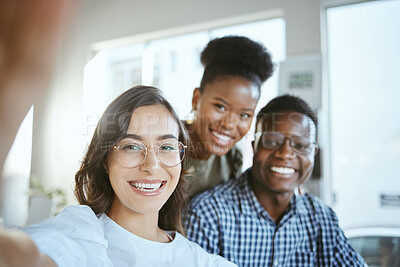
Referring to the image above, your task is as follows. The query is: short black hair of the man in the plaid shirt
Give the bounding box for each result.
[257,94,318,126]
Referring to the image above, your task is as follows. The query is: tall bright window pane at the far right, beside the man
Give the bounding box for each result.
[327,1,400,228]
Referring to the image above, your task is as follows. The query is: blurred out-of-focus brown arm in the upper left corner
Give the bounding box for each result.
[0,0,79,173]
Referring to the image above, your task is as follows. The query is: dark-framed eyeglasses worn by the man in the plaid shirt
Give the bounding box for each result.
[255,132,318,154]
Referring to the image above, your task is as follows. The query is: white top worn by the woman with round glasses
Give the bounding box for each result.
[21,205,236,267]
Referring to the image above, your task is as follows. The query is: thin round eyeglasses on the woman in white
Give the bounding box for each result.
[114,141,186,168]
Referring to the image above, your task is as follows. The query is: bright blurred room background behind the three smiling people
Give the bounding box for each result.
[0,0,400,266]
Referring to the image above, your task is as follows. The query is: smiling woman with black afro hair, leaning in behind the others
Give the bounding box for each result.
[186,36,273,196]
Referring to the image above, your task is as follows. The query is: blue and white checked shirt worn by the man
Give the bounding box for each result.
[184,170,365,267]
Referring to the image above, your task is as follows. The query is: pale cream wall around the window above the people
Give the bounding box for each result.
[26,0,362,207]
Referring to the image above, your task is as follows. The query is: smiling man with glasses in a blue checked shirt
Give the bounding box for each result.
[185,95,365,267]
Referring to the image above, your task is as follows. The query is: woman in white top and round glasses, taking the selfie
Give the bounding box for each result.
[18,86,235,266]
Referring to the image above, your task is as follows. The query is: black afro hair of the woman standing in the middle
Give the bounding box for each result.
[200,36,274,91]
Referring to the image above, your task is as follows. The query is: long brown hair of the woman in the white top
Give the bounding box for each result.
[75,85,188,233]
